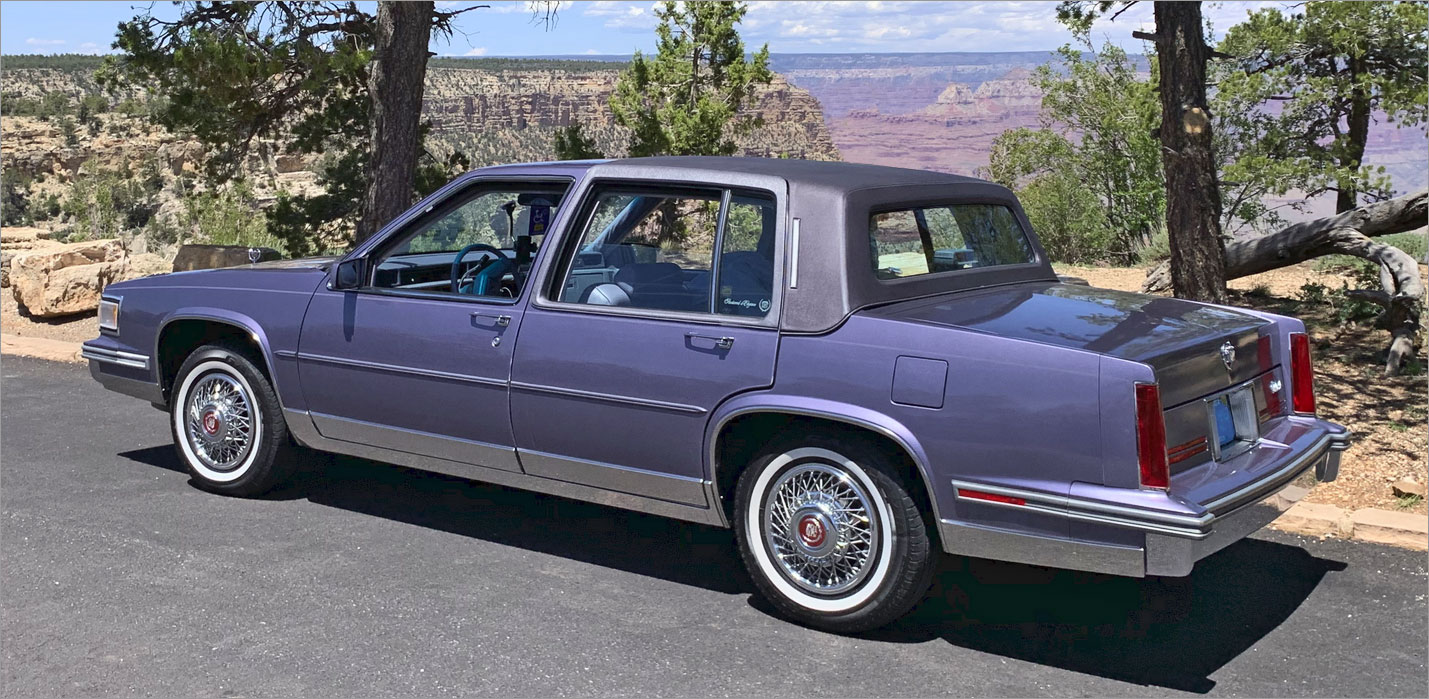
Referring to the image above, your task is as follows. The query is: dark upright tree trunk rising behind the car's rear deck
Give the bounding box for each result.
[1156,1,1226,303]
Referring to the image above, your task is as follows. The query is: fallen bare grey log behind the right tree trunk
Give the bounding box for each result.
[1142,190,1429,376]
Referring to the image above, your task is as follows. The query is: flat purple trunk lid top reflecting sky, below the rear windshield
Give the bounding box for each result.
[872,282,1266,363]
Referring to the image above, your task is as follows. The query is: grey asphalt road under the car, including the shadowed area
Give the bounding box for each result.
[0,357,1429,696]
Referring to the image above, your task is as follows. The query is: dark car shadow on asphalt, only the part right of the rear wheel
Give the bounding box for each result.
[867,539,1348,693]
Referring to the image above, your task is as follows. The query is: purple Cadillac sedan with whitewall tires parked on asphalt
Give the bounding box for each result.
[84,157,1349,632]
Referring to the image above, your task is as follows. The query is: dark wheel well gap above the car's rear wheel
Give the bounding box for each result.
[713,412,936,530]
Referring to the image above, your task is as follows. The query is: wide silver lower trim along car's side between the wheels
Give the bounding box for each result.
[283,409,725,526]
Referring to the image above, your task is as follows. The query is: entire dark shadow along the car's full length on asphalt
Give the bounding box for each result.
[120,446,1346,693]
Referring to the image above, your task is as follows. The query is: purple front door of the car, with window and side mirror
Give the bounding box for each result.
[297,180,566,473]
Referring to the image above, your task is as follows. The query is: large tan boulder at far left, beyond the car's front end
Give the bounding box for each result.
[10,239,129,317]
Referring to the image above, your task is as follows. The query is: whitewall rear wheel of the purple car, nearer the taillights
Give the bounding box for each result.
[735,433,936,633]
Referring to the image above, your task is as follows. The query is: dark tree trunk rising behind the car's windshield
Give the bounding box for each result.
[357,1,434,242]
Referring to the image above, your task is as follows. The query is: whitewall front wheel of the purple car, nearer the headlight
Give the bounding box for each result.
[169,344,293,496]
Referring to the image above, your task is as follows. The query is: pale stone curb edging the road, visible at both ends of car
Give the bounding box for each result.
[0,333,1429,550]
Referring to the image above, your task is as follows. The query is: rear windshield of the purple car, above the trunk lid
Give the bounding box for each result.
[869,204,1036,280]
